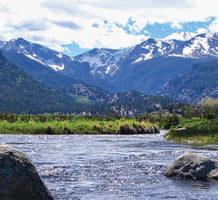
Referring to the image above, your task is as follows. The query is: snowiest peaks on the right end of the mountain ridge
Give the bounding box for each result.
[131,33,218,64]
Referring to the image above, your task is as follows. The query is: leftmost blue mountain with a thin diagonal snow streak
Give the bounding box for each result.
[0,38,84,88]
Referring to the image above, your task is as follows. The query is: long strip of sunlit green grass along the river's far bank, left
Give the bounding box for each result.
[0,117,158,134]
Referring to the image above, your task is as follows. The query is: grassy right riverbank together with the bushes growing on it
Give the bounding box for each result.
[166,97,218,145]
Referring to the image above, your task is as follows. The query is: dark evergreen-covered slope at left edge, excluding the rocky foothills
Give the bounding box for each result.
[0,50,78,113]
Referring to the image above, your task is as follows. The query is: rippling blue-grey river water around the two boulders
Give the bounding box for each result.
[0,130,218,200]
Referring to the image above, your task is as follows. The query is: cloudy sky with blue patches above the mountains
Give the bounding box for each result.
[0,0,218,56]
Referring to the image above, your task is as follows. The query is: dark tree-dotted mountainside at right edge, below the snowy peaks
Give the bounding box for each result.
[159,60,218,103]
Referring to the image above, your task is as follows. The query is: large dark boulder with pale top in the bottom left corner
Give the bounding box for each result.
[0,143,54,200]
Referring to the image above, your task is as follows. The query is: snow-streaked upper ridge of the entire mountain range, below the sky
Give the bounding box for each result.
[0,32,218,79]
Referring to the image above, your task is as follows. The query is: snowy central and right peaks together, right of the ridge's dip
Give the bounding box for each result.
[71,32,218,78]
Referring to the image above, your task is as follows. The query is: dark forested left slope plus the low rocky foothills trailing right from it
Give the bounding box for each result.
[0,50,181,116]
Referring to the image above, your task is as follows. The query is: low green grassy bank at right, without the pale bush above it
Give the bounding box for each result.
[165,118,218,146]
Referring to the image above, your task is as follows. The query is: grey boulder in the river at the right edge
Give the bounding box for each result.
[165,153,218,180]
